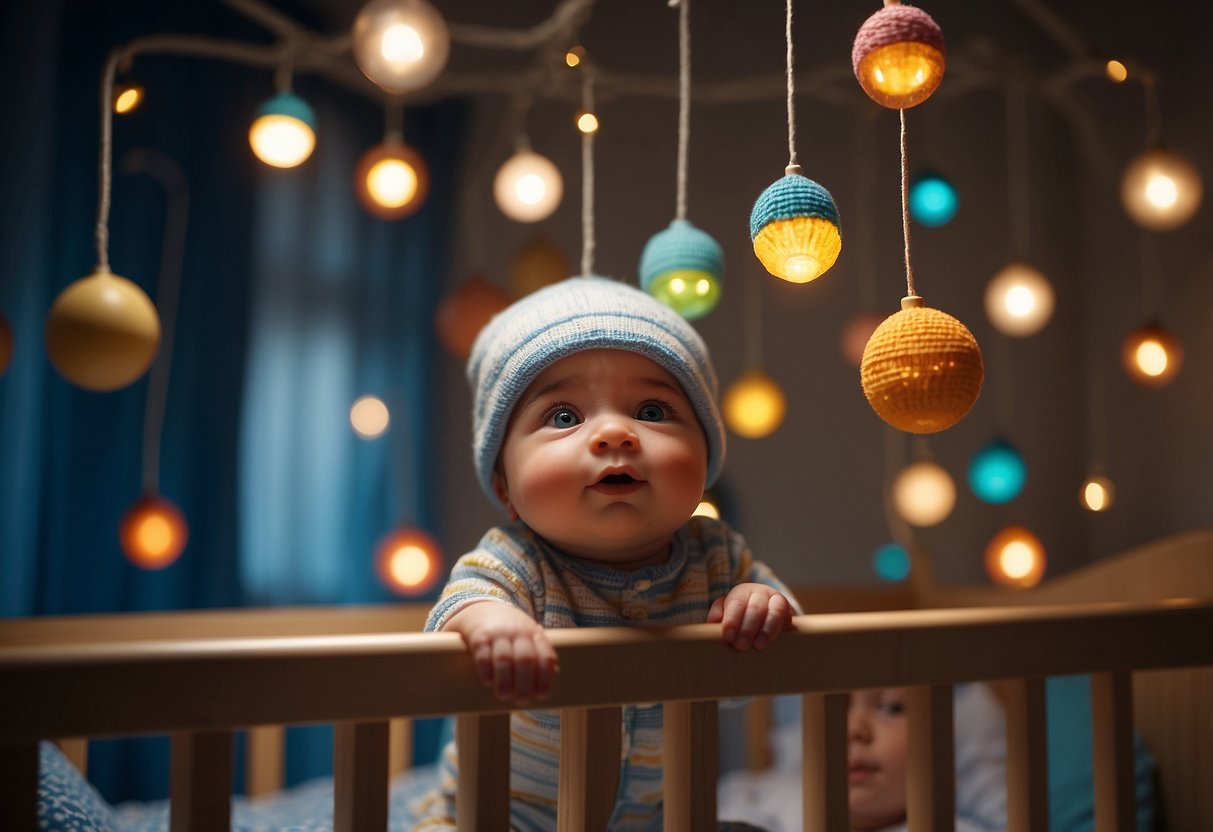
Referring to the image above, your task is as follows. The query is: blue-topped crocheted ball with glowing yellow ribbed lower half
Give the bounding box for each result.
[750,166,842,283]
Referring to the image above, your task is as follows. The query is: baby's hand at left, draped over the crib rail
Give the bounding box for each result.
[443,602,559,705]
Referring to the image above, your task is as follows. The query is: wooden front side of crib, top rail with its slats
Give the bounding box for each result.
[0,599,1213,831]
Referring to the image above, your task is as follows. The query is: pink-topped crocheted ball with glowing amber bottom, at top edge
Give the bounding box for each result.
[850,2,947,109]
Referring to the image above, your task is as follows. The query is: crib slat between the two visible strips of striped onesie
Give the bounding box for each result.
[556,707,622,832]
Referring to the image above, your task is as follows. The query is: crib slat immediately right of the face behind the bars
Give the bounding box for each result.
[906,685,956,832]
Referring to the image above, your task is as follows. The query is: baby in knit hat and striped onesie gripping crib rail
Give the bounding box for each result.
[416,278,799,830]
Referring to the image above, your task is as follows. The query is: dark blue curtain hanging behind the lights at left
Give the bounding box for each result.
[0,0,465,800]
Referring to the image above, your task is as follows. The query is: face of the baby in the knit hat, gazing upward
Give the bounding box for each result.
[495,349,707,569]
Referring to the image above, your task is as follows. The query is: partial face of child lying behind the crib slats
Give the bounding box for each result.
[847,688,907,830]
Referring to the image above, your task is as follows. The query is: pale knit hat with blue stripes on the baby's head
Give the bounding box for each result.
[467,277,724,509]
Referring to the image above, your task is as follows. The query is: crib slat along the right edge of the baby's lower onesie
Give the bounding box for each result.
[662,700,719,832]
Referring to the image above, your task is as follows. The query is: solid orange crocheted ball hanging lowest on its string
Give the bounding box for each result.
[859,295,984,433]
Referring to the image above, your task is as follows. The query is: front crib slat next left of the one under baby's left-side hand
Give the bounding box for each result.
[332,719,389,832]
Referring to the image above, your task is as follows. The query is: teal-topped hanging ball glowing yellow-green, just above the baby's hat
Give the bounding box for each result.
[640,220,724,320]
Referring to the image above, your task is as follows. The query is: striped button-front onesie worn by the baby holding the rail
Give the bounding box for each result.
[414,517,801,832]
